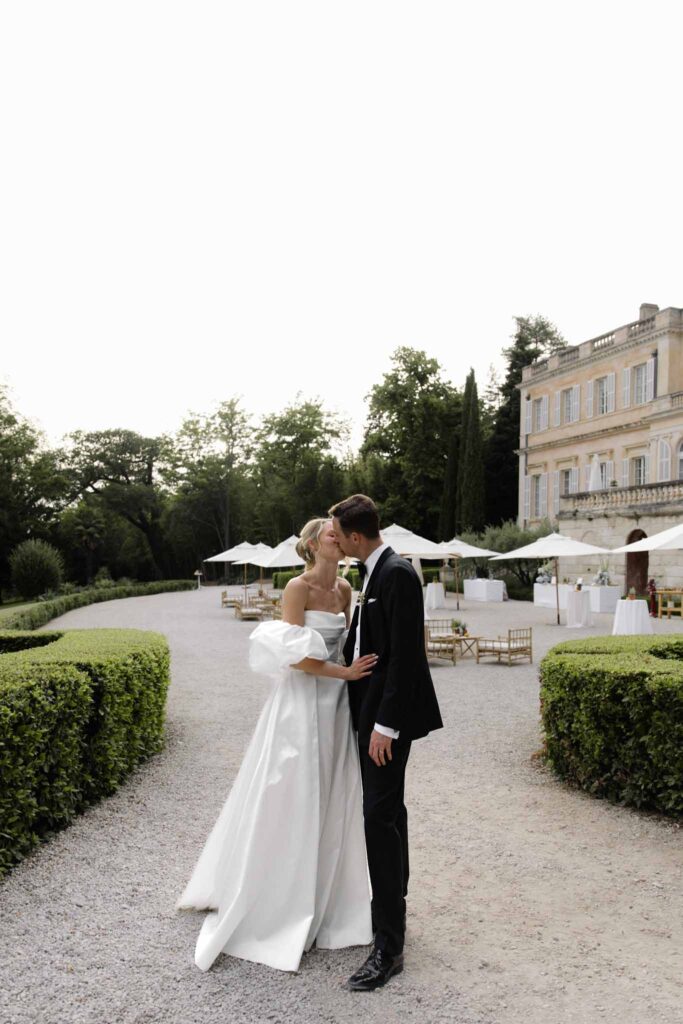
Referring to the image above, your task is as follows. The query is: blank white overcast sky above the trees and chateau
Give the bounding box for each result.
[0,0,683,441]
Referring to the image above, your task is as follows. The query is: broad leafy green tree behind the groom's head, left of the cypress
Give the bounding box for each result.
[360,347,461,538]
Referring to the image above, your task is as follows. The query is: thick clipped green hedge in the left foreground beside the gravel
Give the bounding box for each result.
[0,630,169,876]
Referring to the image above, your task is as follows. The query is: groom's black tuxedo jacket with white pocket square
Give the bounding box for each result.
[344,548,443,740]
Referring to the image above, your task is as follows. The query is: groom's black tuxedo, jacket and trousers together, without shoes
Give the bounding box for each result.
[344,548,443,956]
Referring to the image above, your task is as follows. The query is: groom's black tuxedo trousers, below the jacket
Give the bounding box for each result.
[358,737,411,956]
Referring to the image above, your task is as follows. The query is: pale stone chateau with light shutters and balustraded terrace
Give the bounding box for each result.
[519,304,683,593]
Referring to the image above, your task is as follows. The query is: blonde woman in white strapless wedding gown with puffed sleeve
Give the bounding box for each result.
[177,519,376,971]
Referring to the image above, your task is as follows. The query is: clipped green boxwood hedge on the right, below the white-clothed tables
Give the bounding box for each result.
[541,636,683,816]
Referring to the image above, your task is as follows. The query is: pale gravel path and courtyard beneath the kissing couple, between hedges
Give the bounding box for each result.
[0,589,683,1024]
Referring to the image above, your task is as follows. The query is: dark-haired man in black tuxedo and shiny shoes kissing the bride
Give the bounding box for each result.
[329,495,443,991]
